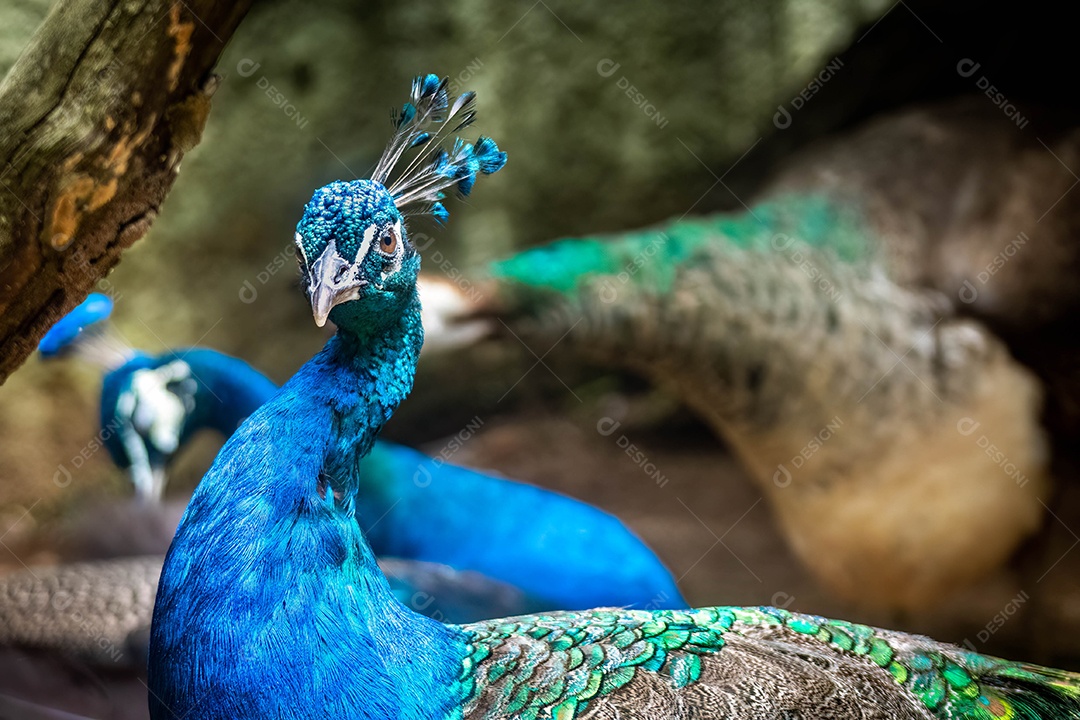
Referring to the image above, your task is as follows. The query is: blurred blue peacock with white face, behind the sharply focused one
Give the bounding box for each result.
[40,294,686,622]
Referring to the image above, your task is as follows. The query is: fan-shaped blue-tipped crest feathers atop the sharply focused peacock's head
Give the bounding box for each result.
[372,73,507,222]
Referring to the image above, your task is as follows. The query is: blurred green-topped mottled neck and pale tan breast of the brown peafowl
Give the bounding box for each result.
[478,187,1049,608]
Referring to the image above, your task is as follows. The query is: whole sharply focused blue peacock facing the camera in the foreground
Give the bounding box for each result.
[149,74,1080,720]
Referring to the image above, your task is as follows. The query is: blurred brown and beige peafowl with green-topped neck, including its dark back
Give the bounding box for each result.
[432,98,1080,611]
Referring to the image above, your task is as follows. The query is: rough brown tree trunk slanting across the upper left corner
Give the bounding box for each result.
[0,0,251,383]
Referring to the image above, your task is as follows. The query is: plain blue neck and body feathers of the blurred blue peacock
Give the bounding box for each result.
[102,334,687,610]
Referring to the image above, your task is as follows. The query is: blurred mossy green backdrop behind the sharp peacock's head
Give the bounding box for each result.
[0,0,888,524]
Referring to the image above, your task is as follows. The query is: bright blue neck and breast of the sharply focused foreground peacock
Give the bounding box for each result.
[149,298,463,720]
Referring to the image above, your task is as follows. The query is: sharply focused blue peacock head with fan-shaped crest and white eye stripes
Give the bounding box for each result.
[296,74,507,327]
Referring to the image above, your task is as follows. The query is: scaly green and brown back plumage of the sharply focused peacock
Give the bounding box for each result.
[457,608,1080,720]
